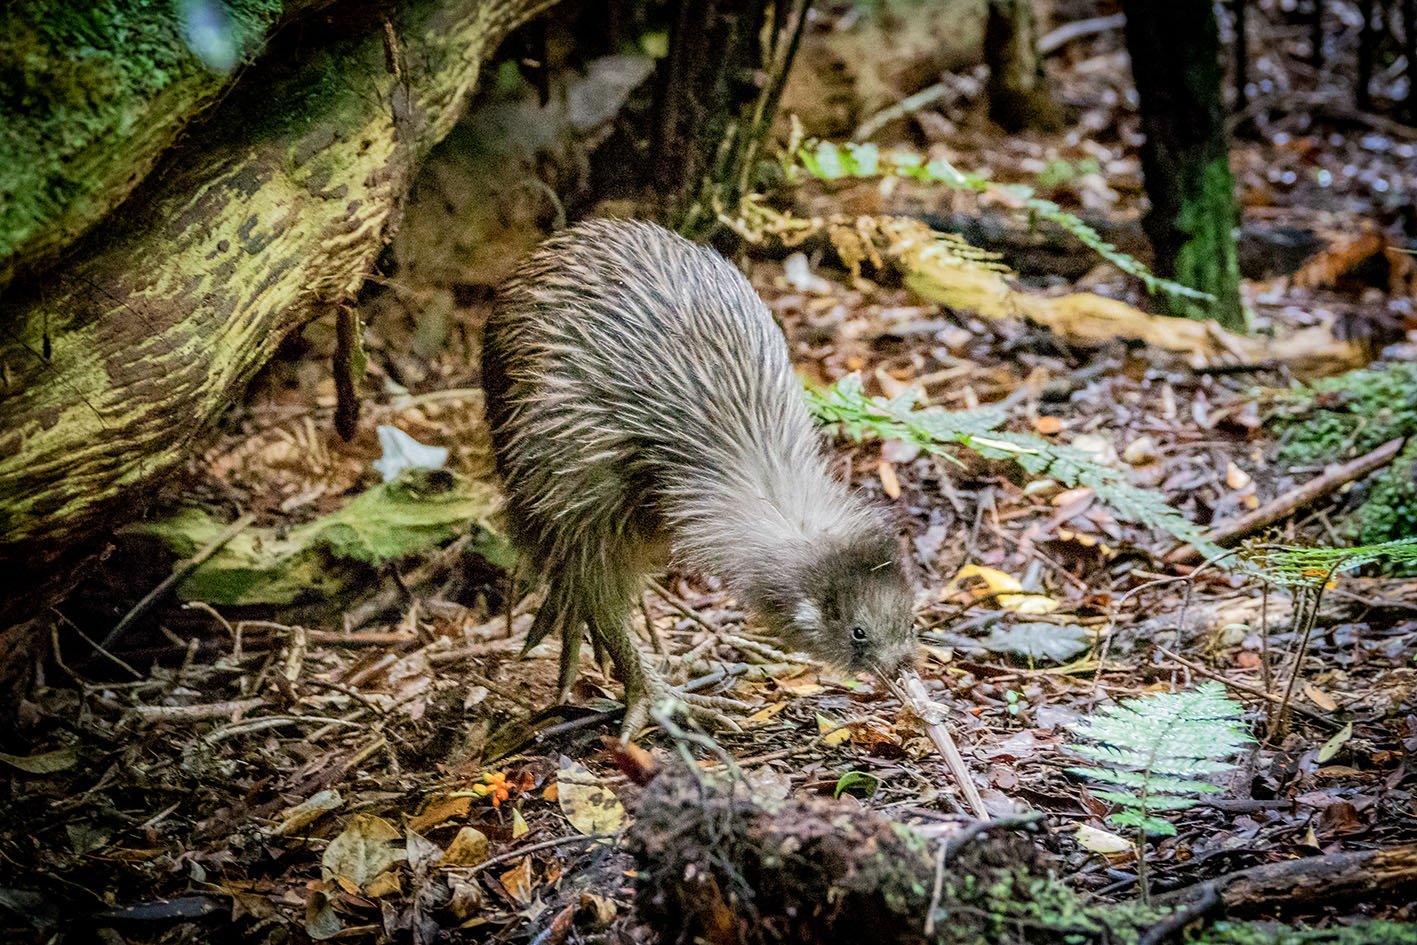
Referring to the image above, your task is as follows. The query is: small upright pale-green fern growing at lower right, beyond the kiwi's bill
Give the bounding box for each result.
[1068,683,1253,898]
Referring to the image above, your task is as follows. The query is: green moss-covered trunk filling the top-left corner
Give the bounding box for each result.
[0,0,316,286]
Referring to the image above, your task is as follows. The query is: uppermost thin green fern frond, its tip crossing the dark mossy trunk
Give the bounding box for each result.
[782,140,1214,302]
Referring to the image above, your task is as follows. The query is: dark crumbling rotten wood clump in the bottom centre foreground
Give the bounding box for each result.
[626,771,1054,945]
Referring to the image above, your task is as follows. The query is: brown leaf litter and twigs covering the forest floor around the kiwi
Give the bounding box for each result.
[0,1,1417,944]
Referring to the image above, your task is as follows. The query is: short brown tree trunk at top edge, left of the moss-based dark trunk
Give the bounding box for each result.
[983,0,1063,133]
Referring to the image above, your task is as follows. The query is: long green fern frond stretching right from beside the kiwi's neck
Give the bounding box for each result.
[808,374,1223,557]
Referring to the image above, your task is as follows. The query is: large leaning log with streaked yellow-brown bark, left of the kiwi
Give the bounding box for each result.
[0,0,551,618]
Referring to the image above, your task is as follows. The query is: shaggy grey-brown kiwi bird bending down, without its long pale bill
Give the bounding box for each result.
[482,221,917,734]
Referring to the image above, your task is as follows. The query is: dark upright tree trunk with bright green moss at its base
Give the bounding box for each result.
[1122,0,1246,329]
